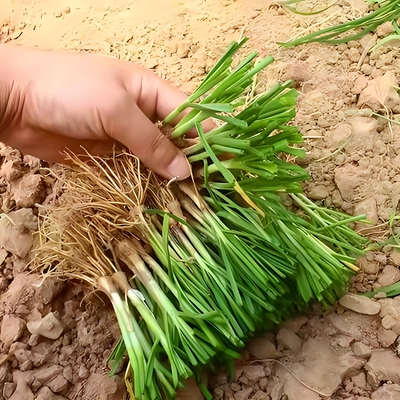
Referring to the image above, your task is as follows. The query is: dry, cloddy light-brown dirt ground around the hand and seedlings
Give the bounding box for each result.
[0,0,400,400]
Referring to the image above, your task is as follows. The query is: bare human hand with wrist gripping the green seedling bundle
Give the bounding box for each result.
[0,45,200,179]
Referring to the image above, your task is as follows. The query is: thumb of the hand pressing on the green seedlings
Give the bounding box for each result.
[110,102,191,180]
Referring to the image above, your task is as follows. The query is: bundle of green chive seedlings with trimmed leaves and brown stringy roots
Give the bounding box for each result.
[35,39,365,400]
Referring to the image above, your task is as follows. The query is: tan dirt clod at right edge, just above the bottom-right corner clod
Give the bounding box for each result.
[365,349,400,384]
